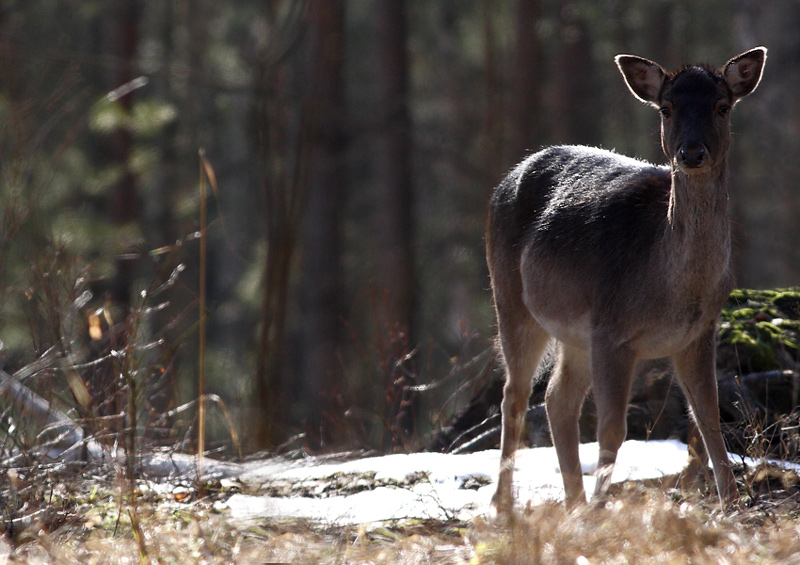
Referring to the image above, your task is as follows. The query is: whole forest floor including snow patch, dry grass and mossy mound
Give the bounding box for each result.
[0,289,800,565]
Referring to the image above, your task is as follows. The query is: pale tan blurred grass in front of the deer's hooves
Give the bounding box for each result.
[473,480,800,564]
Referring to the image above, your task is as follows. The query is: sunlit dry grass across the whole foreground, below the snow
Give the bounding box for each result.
[0,477,800,564]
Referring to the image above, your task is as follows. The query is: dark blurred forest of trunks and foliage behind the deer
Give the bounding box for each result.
[0,0,800,451]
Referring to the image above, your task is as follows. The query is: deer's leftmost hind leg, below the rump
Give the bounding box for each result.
[492,300,549,518]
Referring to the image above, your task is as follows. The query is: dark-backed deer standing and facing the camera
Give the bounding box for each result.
[486,47,767,518]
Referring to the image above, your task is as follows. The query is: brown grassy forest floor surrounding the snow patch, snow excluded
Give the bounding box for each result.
[0,442,800,564]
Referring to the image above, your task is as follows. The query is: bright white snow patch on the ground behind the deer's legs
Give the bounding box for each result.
[220,440,756,526]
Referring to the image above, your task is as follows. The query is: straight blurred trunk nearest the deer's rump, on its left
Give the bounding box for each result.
[375,0,415,450]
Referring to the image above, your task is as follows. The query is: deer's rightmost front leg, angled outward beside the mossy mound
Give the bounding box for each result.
[673,323,738,506]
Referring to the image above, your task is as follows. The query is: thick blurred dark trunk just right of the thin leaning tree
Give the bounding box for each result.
[300,0,345,450]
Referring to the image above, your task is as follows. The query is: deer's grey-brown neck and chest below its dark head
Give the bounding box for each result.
[666,163,730,294]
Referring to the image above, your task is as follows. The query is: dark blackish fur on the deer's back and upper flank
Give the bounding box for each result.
[489,146,670,286]
